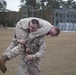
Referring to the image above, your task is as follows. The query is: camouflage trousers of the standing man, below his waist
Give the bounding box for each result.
[18,60,41,75]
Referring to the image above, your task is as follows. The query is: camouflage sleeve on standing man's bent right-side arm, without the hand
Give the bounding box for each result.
[32,39,46,59]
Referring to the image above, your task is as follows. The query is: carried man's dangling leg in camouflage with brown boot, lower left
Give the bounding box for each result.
[0,44,23,73]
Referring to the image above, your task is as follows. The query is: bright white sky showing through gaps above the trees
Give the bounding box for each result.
[5,0,76,11]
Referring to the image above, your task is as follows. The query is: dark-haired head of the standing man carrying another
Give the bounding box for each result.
[29,19,40,32]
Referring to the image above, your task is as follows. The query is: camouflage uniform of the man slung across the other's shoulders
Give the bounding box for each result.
[4,17,53,53]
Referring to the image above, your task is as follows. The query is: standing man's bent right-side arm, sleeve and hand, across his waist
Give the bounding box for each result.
[26,39,46,60]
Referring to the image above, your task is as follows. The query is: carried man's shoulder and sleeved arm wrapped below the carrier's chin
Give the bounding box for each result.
[29,19,53,39]
